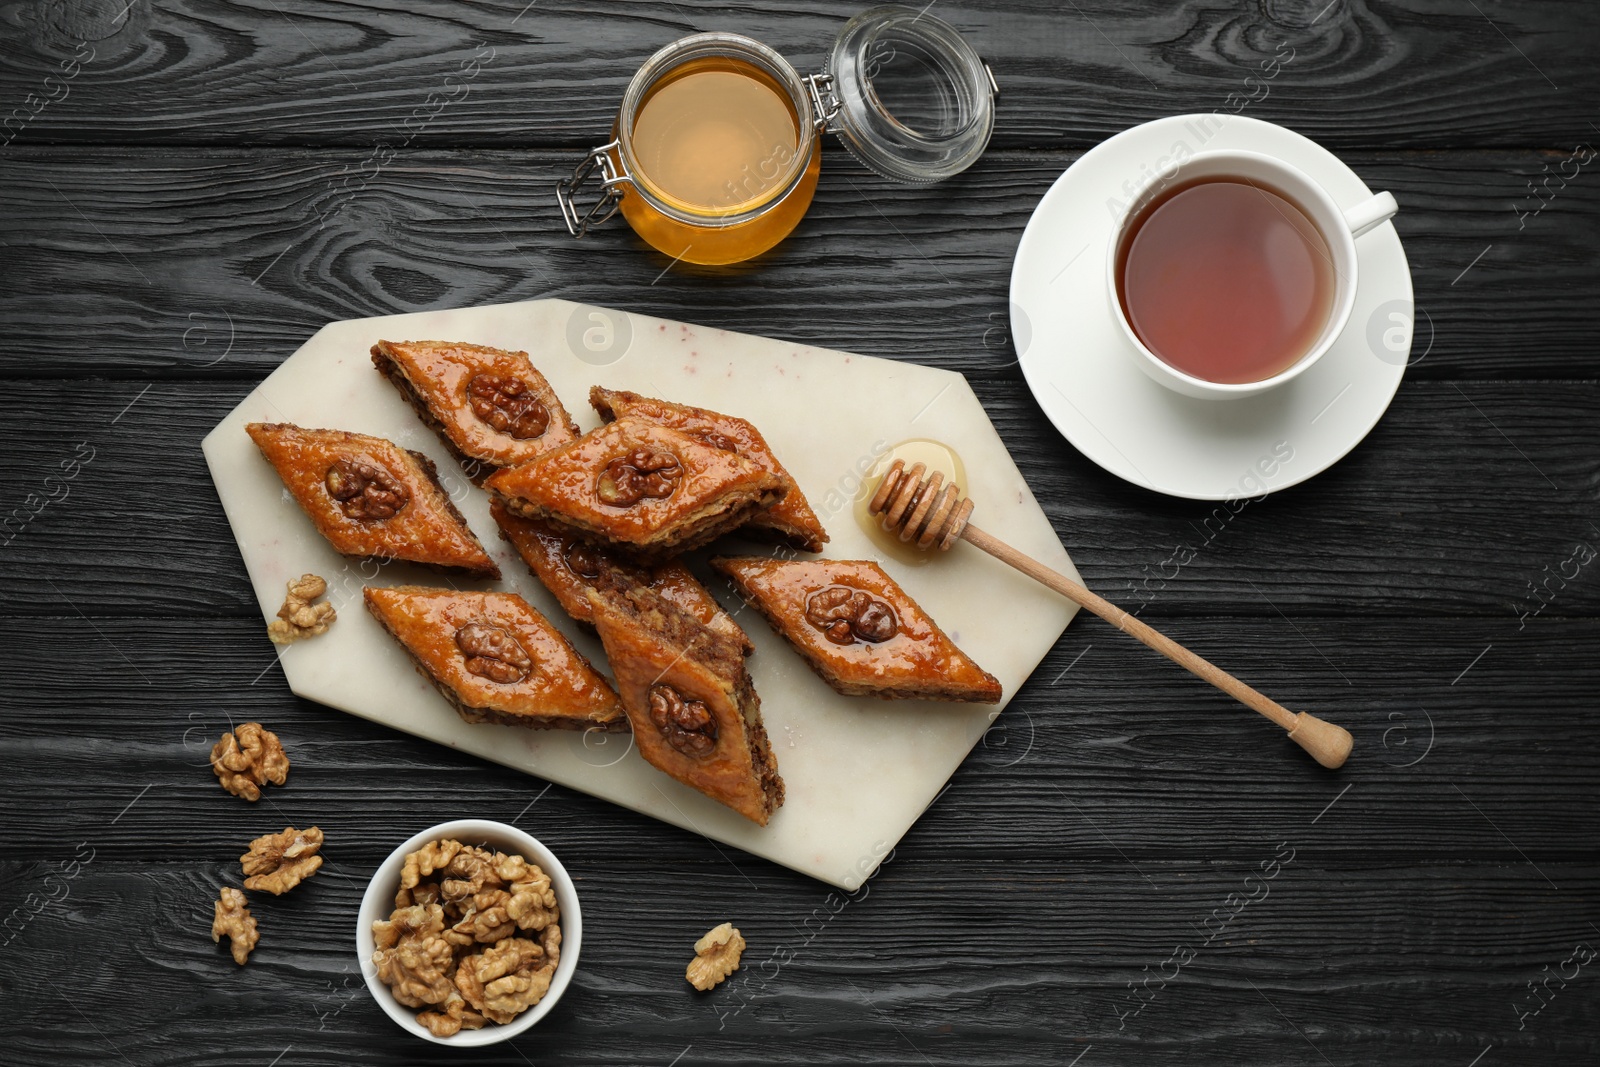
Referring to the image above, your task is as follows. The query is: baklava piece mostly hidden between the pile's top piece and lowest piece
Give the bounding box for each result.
[490,501,755,656]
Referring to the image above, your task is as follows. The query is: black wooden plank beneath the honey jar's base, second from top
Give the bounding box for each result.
[0,146,1600,382]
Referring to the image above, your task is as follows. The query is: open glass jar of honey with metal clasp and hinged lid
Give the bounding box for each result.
[557,6,998,264]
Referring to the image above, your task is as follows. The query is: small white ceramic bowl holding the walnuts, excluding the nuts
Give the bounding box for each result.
[355,819,584,1048]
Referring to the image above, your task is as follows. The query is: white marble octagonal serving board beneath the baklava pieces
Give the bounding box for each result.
[203,299,1077,889]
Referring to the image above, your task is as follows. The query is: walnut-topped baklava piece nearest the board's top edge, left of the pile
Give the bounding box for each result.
[373,341,578,485]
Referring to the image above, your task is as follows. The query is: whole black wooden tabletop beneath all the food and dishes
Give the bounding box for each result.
[0,0,1600,1067]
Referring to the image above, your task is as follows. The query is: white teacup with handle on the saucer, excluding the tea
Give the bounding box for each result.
[1106,149,1400,400]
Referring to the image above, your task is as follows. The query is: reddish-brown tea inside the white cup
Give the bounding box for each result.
[1115,174,1338,384]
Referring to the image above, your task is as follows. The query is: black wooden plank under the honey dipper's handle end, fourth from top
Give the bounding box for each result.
[0,616,1600,857]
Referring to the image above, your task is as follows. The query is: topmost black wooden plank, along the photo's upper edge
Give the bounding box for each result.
[0,0,1600,149]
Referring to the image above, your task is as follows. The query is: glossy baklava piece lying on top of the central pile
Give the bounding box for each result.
[486,419,784,563]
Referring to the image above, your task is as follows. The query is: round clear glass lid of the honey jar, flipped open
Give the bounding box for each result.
[826,5,995,184]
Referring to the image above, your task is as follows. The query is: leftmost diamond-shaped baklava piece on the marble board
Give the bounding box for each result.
[245,422,499,577]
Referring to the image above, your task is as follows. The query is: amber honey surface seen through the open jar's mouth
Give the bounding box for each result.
[632,58,800,214]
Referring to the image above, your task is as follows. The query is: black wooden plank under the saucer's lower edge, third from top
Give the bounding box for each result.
[0,374,1600,617]
